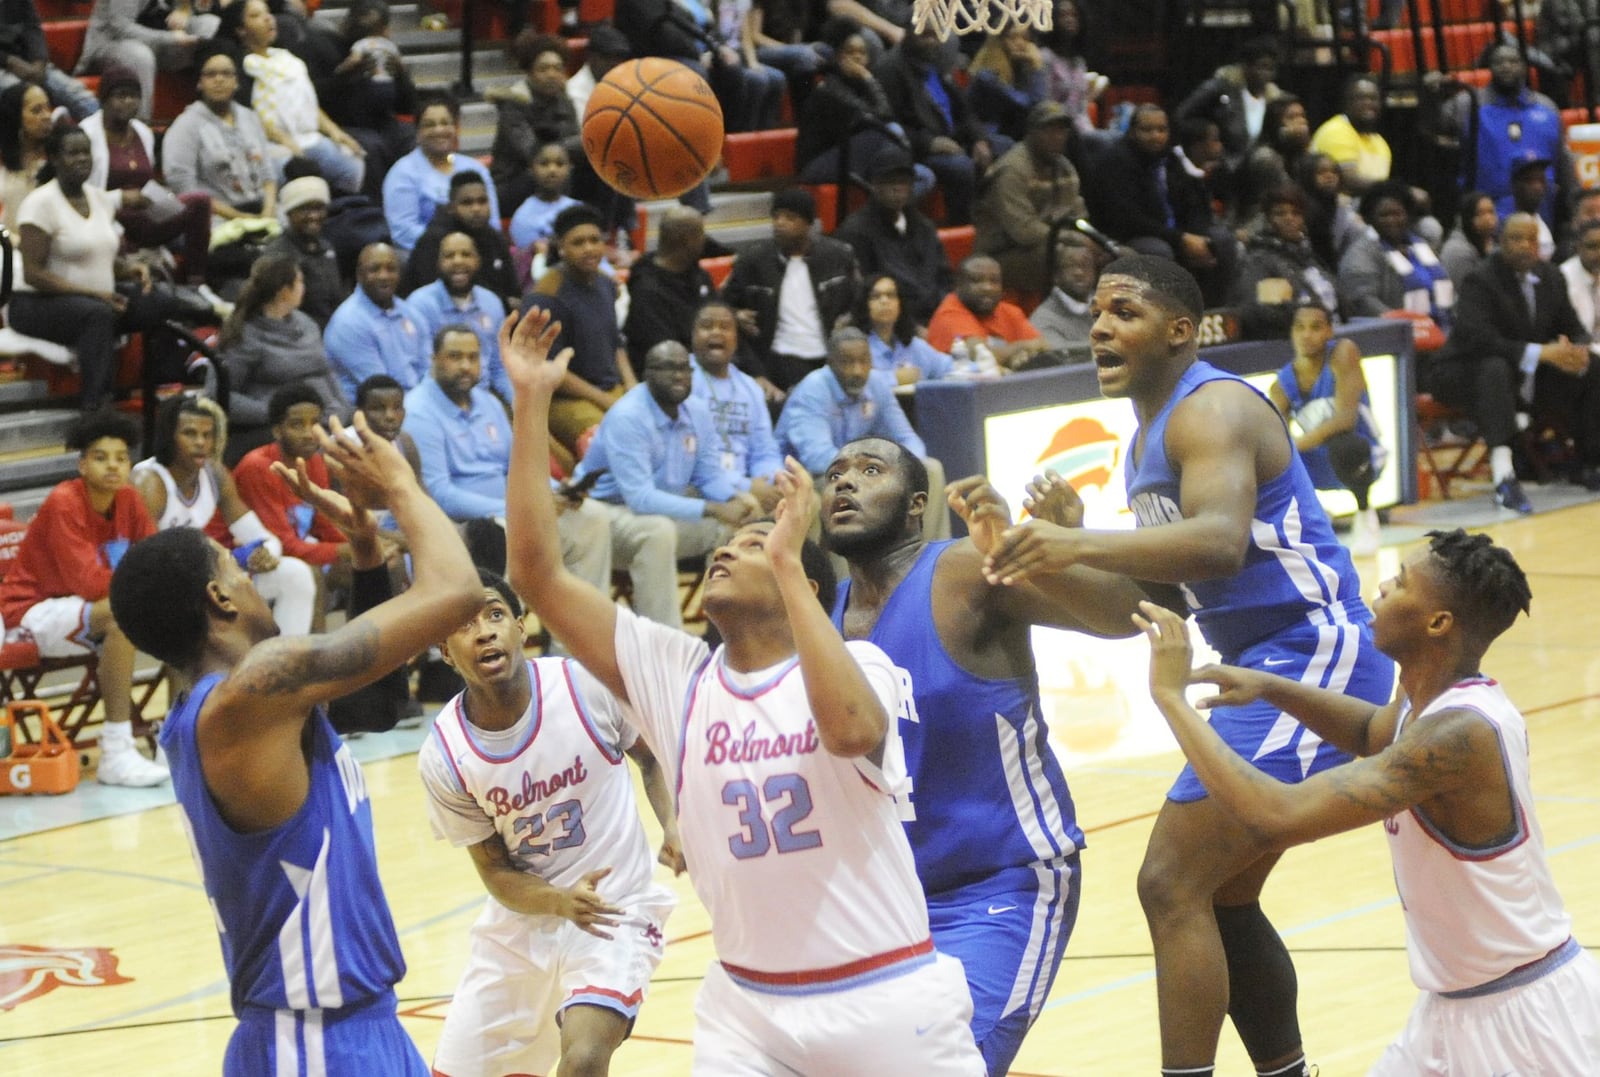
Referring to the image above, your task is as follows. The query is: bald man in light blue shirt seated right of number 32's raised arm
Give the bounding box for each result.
[574,341,758,559]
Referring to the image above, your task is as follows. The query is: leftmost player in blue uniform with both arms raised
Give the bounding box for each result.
[110,414,483,1077]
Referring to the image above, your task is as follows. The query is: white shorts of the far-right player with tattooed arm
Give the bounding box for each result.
[1370,951,1600,1077]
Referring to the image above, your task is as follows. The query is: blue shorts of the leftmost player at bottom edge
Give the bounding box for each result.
[222,992,429,1077]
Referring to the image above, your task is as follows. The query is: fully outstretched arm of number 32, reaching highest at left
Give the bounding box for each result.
[499,309,627,701]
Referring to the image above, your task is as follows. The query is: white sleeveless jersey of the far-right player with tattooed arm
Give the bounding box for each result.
[1384,679,1573,991]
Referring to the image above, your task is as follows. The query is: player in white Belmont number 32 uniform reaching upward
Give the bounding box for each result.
[501,314,984,1077]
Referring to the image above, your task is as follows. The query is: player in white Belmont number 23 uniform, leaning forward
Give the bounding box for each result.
[418,571,682,1077]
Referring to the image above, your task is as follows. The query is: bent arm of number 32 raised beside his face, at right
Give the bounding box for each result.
[766,456,890,763]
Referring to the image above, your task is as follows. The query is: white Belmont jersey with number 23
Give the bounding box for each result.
[418,658,674,907]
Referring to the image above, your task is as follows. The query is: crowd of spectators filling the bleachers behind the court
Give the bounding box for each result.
[9,0,1600,776]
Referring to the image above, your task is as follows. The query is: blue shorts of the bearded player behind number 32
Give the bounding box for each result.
[928,853,1082,1077]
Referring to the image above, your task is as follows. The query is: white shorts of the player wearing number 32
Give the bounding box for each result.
[693,954,986,1077]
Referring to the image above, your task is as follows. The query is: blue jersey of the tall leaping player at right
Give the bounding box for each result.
[1126,360,1371,661]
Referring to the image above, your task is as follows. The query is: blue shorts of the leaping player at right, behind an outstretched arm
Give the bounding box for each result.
[1166,621,1395,803]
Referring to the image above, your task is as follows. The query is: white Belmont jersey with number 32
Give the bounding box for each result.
[618,610,930,984]
